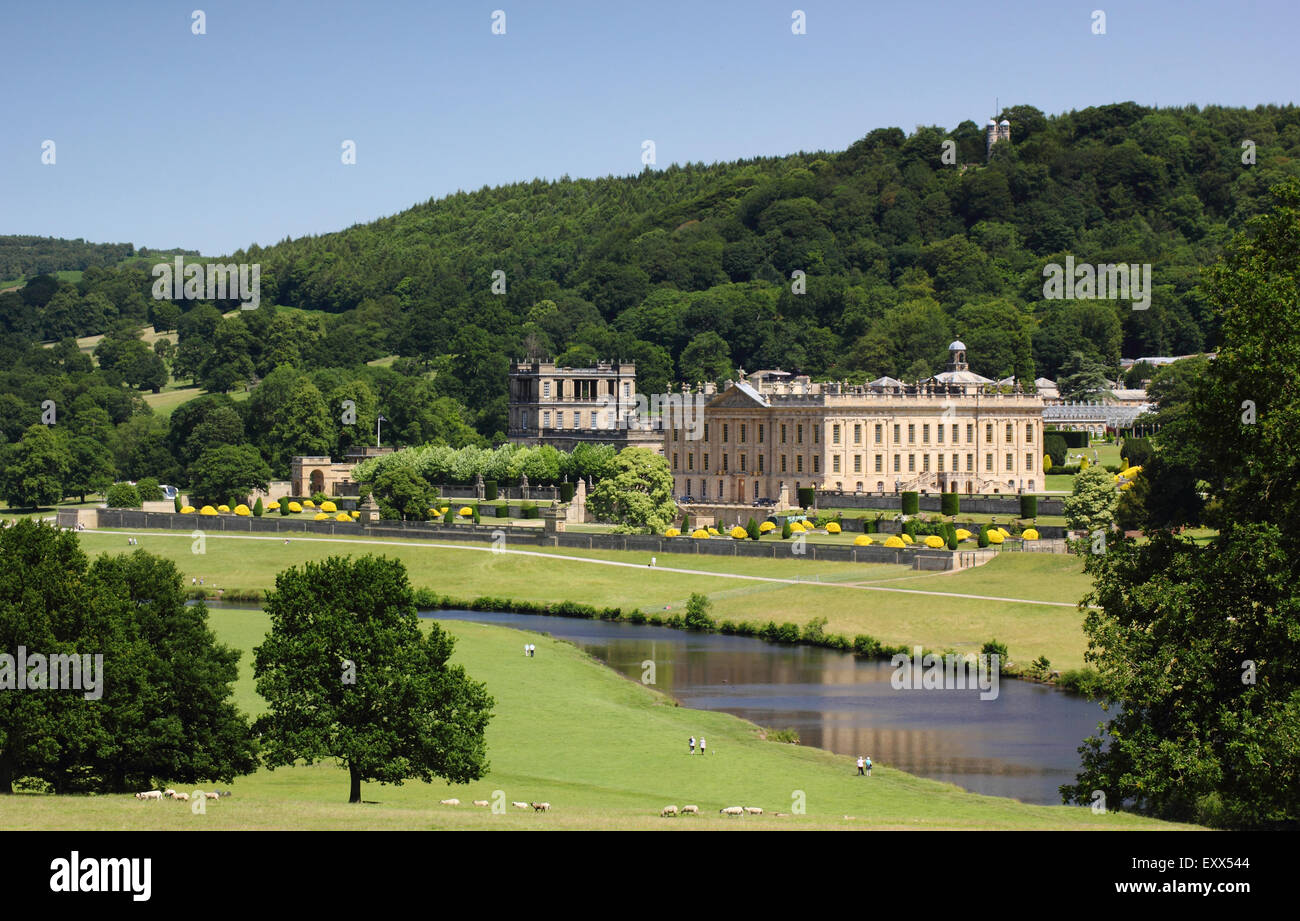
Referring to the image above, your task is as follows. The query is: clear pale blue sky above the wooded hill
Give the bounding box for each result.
[0,0,1300,255]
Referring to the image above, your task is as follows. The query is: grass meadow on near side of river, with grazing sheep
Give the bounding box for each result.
[0,610,1183,830]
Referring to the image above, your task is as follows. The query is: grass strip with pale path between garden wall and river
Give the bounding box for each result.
[81,523,1087,669]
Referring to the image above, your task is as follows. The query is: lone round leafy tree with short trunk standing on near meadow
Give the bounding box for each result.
[254,555,493,803]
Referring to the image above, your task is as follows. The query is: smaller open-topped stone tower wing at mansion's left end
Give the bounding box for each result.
[506,362,663,451]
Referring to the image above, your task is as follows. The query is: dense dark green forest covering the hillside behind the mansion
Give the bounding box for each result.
[0,103,1300,496]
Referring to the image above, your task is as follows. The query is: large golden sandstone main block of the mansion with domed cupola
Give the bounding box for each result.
[662,342,1044,503]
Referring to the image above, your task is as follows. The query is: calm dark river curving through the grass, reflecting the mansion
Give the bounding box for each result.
[432,611,1105,804]
